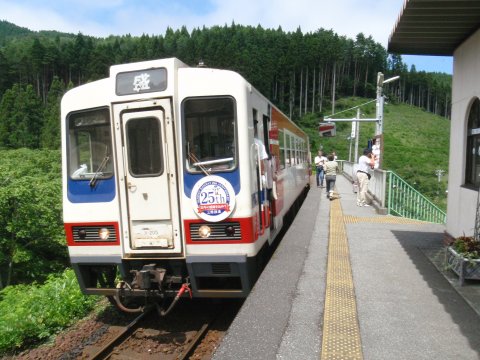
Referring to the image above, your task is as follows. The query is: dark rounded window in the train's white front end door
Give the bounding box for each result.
[126,117,163,177]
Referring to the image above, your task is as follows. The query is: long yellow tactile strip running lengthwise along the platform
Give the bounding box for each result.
[321,201,363,360]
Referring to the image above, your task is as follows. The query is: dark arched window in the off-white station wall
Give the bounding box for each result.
[465,98,480,188]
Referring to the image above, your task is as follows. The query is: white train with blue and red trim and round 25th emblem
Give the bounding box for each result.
[61,58,310,311]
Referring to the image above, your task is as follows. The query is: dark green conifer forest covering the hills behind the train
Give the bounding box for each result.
[0,21,451,149]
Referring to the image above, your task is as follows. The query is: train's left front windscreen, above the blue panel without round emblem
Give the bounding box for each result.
[68,108,113,180]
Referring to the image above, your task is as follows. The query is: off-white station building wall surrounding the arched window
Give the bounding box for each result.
[446,30,480,236]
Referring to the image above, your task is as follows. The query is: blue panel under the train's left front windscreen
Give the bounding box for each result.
[67,176,115,203]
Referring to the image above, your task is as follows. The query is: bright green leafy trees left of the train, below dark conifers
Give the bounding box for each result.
[0,149,68,288]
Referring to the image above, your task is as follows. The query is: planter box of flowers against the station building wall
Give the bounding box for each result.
[445,235,480,286]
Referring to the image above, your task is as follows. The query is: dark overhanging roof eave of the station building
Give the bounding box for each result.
[388,0,480,56]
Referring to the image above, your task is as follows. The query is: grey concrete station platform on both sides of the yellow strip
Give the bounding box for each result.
[213,176,480,360]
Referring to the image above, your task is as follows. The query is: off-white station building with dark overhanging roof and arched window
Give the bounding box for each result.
[388,0,480,237]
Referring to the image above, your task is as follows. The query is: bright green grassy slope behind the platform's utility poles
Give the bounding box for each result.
[302,98,450,209]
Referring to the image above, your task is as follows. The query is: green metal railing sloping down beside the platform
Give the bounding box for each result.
[387,171,447,224]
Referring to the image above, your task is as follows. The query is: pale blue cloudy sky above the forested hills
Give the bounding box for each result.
[0,0,453,74]
